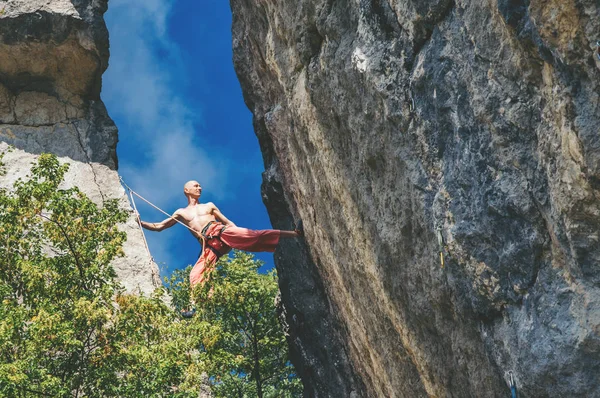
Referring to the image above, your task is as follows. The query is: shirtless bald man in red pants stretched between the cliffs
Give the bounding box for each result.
[140,181,302,287]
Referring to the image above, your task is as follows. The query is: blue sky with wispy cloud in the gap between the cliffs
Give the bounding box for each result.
[102,0,273,275]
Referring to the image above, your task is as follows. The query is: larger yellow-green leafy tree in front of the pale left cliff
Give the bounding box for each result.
[0,155,203,397]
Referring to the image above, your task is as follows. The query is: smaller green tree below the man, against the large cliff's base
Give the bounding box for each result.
[167,251,302,398]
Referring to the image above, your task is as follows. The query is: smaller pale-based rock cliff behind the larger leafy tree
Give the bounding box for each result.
[0,0,160,293]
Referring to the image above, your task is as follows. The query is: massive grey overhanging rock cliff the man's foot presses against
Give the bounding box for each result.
[231,0,600,397]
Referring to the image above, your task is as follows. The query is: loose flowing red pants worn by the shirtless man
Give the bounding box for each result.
[190,222,281,287]
